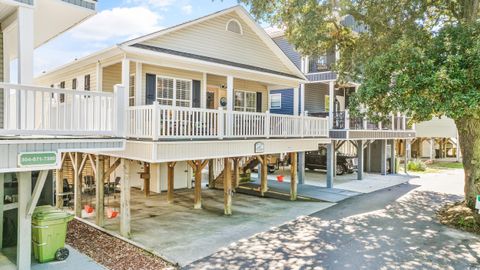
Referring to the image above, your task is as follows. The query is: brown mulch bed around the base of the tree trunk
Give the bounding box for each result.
[437,202,480,234]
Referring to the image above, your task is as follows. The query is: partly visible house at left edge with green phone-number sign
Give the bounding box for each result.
[0,0,124,269]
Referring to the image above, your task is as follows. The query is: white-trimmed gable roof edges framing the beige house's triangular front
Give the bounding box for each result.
[119,5,306,80]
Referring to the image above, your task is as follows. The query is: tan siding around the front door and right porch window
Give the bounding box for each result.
[207,74,268,112]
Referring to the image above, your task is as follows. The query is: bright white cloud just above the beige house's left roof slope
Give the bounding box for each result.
[70,6,163,42]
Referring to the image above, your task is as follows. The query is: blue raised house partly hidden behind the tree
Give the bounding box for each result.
[267,22,415,179]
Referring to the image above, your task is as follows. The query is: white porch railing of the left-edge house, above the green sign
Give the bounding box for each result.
[0,83,124,136]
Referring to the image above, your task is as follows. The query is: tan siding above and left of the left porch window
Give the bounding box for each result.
[140,64,203,104]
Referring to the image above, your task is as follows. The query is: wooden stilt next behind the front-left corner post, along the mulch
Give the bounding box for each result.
[95,155,105,227]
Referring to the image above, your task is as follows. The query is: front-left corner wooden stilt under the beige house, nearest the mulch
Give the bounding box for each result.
[120,159,130,238]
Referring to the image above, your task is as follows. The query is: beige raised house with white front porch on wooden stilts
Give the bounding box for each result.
[35,6,330,236]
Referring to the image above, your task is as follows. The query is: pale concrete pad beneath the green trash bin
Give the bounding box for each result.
[0,245,105,270]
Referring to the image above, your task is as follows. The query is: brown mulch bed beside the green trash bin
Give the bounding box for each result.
[66,219,176,270]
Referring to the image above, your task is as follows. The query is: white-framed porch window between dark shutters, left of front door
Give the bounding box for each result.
[157,76,192,107]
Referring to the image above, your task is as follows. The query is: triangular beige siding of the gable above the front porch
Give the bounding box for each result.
[143,12,291,76]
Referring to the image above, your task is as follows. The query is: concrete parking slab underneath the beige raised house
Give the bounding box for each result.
[87,188,334,266]
